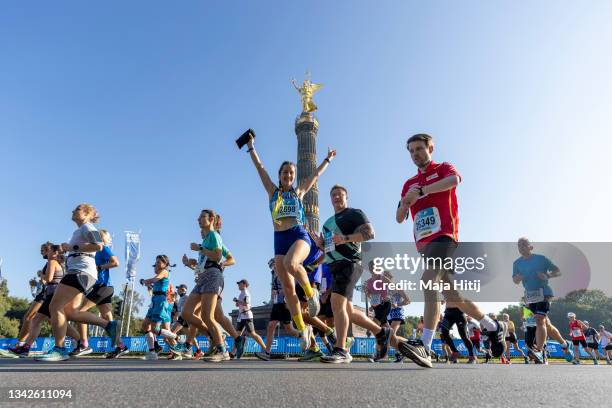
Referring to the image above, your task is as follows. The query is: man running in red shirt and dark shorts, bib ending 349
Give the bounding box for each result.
[395,134,505,367]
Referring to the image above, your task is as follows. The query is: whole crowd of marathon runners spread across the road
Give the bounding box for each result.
[0,134,612,367]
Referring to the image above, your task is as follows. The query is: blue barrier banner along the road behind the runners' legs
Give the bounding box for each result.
[0,336,603,358]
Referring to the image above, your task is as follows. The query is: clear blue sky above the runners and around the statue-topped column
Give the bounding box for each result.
[0,0,612,313]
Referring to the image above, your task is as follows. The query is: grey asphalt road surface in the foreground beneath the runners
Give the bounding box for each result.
[0,358,612,408]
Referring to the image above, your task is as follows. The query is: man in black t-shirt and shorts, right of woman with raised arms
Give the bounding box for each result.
[317,185,391,363]
